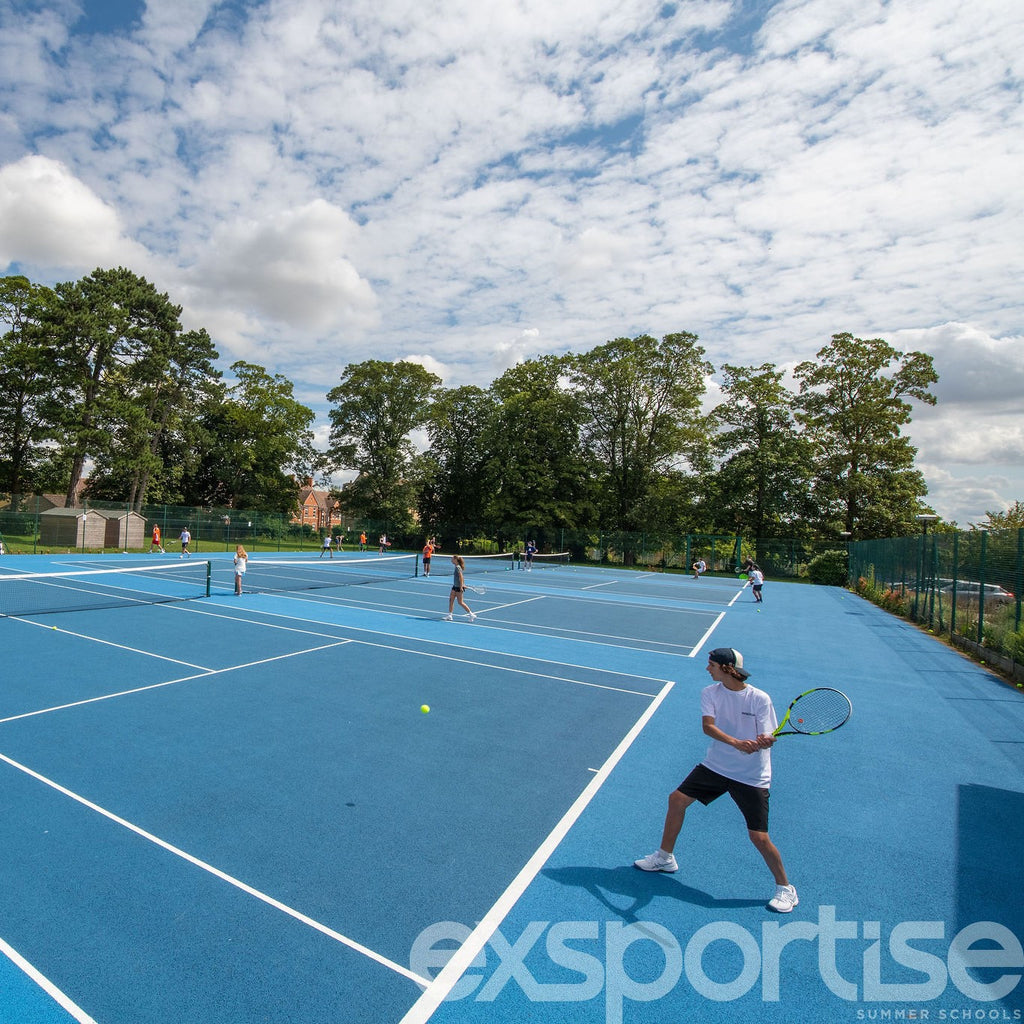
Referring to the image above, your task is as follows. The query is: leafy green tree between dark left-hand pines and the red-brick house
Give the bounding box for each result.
[182,360,315,512]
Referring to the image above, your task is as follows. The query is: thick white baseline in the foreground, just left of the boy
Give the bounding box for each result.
[399,683,674,1024]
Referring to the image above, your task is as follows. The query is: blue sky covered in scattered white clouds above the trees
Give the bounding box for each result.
[0,0,1024,525]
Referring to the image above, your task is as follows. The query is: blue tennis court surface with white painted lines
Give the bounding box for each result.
[0,554,1024,1024]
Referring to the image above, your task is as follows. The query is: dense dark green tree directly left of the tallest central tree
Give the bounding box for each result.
[484,355,591,531]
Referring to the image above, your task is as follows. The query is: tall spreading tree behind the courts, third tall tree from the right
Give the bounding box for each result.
[570,333,712,529]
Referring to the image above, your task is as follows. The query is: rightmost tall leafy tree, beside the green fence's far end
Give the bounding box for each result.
[794,334,938,537]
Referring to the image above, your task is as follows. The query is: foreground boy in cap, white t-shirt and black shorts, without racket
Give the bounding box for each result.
[634,647,800,913]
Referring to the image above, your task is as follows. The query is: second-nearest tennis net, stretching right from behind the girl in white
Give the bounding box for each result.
[213,554,420,594]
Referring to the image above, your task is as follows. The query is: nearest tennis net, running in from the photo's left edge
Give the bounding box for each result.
[0,559,210,617]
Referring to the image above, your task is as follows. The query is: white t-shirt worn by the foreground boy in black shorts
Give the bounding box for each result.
[700,683,778,790]
